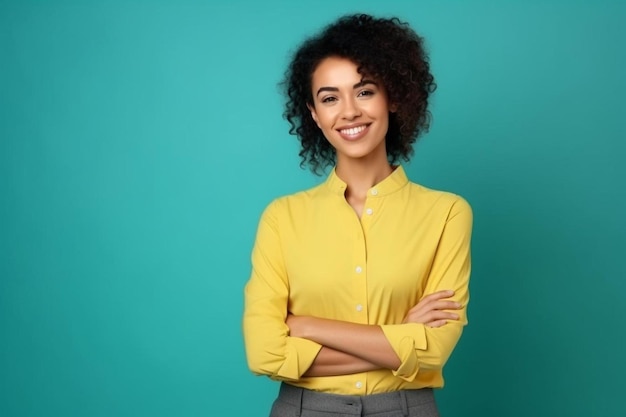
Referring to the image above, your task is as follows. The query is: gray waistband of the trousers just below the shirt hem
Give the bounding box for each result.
[278,382,435,416]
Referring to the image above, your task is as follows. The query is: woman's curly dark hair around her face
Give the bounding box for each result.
[280,14,437,174]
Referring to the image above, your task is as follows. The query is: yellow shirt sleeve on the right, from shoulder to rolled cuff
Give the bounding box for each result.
[381,197,472,381]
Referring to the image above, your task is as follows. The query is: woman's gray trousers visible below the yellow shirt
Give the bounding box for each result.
[270,383,439,417]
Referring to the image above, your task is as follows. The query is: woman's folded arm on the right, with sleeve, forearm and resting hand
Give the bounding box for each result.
[287,199,472,381]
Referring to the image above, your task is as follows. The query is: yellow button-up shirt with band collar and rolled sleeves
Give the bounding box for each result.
[243,167,472,395]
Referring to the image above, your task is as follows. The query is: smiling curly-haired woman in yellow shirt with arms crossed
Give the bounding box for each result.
[244,15,472,416]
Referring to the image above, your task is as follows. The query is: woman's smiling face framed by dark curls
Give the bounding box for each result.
[309,57,394,164]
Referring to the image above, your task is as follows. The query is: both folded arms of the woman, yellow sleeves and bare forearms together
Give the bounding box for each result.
[244,199,471,381]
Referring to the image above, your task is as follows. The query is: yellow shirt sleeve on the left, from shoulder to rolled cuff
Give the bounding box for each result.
[243,200,322,381]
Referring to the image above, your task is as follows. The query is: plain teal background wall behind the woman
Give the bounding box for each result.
[0,0,626,417]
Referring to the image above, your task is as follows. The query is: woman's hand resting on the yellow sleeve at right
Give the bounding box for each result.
[402,290,463,327]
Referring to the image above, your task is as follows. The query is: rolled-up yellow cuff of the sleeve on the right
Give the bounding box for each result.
[381,323,428,382]
